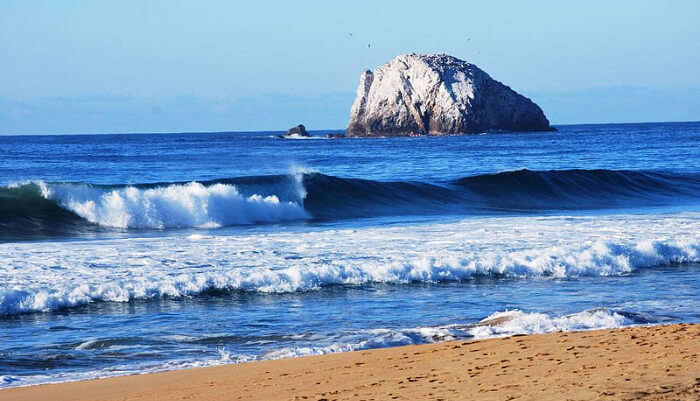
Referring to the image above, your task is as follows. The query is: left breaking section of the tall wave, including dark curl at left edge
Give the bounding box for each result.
[0,175,310,239]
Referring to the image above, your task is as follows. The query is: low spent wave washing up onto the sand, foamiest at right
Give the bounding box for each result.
[0,308,660,389]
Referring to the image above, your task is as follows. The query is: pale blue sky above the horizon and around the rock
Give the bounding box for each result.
[0,0,700,134]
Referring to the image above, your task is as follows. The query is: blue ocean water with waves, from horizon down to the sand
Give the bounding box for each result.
[0,123,700,387]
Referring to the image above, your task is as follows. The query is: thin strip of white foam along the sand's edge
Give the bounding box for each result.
[0,309,635,388]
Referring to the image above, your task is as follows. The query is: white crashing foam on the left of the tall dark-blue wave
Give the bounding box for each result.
[37,182,309,228]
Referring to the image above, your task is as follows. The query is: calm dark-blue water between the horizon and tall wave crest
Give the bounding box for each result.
[0,123,700,184]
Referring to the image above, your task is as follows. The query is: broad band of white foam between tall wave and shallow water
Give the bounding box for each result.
[0,213,700,315]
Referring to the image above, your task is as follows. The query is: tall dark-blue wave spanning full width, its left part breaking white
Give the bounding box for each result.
[0,170,700,240]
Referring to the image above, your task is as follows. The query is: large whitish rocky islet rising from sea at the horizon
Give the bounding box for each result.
[347,54,552,137]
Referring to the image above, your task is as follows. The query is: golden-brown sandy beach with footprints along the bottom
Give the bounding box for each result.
[0,324,700,401]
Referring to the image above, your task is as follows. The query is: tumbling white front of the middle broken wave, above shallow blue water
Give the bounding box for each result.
[0,234,700,316]
